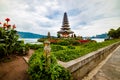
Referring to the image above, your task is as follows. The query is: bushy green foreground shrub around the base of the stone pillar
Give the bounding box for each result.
[28,51,71,80]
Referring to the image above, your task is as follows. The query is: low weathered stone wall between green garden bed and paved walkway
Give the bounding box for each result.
[58,42,120,80]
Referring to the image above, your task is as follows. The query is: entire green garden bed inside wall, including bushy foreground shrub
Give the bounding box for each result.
[28,40,119,80]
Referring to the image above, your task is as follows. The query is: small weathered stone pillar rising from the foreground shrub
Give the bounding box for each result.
[44,40,51,68]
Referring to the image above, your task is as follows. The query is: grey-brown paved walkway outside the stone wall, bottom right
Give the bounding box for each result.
[92,46,120,80]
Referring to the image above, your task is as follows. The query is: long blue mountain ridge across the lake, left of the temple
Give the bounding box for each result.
[18,31,46,38]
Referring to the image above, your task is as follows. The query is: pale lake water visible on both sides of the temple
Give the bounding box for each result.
[19,38,104,44]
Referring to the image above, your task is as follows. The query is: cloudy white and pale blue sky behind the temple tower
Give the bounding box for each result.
[0,0,120,36]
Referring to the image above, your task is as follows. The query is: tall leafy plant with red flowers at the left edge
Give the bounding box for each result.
[0,18,19,57]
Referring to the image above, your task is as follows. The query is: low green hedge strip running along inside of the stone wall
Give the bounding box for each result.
[52,39,120,62]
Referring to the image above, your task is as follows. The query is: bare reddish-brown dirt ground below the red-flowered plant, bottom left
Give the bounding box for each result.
[0,50,33,80]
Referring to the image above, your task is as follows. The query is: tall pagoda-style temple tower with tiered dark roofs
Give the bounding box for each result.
[57,12,74,38]
